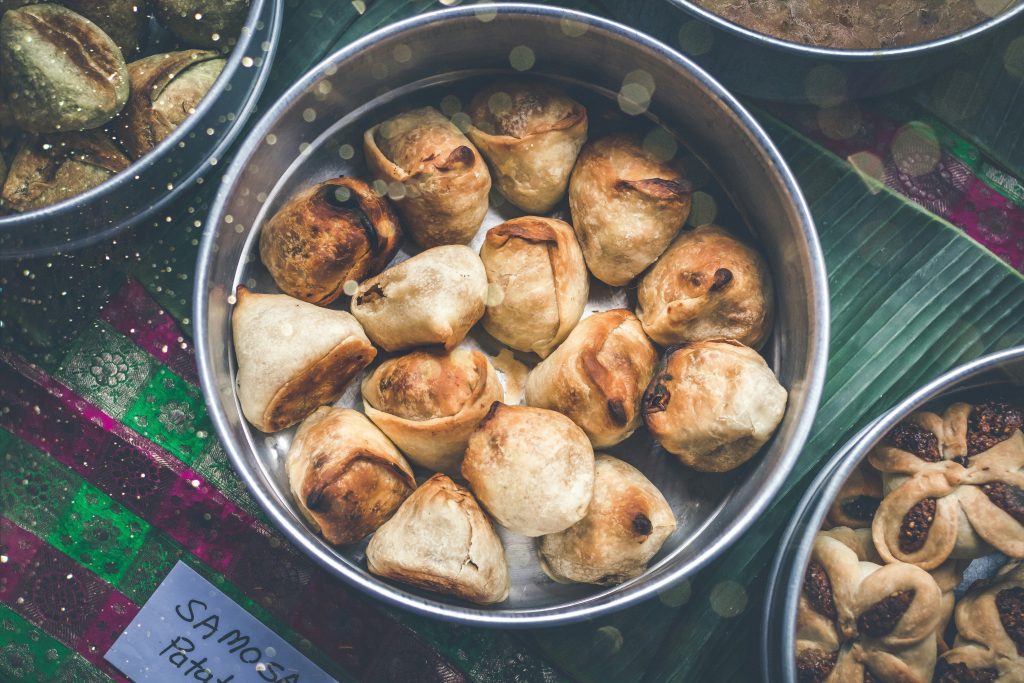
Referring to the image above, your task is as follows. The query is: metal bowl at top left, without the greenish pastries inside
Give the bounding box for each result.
[0,0,284,260]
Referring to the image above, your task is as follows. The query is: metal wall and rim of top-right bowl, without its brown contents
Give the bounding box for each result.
[669,0,1024,104]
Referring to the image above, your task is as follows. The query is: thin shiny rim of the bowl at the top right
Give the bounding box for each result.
[667,0,1024,61]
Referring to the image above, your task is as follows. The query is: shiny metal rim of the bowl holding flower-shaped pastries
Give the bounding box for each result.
[761,346,1024,681]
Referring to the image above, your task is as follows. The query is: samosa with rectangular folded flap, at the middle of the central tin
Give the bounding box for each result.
[480,216,590,358]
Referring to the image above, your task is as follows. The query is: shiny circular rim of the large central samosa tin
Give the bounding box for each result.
[193,3,829,628]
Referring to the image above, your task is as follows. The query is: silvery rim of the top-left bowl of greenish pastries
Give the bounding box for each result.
[0,0,285,254]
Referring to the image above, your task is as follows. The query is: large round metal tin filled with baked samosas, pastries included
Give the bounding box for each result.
[195,5,827,625]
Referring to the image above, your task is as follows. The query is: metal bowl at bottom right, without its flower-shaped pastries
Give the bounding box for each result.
[761,346,1024,682]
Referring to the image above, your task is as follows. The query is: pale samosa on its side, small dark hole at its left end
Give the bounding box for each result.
[352,245,487,351]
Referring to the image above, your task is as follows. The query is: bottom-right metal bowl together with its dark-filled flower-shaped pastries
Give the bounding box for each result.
[765,348,1024,683]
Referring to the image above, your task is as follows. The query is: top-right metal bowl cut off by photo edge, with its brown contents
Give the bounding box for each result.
[669,0,1024,104]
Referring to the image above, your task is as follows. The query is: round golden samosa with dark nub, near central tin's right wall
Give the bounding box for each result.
[637,224,774,349]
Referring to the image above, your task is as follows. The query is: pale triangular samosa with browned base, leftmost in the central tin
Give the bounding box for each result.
[231,287,377,432]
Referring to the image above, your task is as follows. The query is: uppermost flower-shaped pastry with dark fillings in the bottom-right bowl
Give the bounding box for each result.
[868,401,1024,569]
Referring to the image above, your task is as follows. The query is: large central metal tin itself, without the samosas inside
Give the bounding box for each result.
[194,4,828,627]
